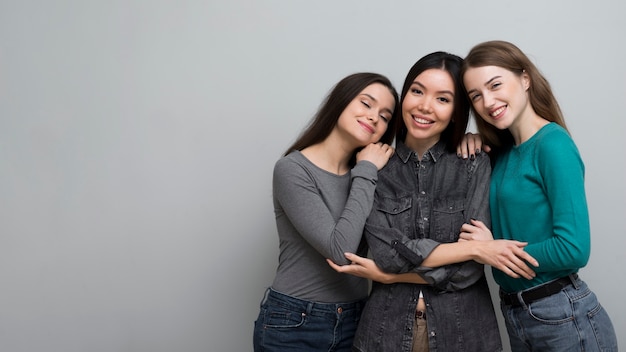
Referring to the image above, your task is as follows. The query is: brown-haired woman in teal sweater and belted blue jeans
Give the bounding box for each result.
[463,41,617,352]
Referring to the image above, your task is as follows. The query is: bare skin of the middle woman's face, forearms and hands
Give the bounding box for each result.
[328,69,539,292]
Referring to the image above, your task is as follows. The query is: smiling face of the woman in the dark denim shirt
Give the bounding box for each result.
[402,69,456,151]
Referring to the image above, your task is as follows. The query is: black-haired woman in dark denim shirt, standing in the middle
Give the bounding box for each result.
[330,52,534,352]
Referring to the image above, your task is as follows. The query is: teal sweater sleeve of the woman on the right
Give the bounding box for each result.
[526,132,591,272]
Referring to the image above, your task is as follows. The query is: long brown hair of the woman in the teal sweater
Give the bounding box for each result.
[461,40,567,151]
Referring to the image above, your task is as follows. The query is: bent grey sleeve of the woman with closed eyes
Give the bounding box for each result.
[273,158,378,265]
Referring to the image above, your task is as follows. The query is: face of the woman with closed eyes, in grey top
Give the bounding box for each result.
[336,83,395,147]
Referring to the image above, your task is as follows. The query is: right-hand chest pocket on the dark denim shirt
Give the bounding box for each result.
[431,199,465,242]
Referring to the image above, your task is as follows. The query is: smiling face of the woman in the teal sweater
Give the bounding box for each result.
[463,66,530,130]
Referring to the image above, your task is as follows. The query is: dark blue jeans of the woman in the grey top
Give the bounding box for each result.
[253,288,365,352]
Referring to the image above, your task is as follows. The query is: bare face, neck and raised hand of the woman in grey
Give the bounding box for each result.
[301,83,395,175]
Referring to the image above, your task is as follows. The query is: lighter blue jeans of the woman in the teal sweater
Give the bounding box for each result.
[500,278,617,352]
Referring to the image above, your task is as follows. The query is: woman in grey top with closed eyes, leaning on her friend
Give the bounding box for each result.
[253,73,420,351]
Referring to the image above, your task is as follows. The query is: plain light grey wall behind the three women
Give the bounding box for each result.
[0,0,626,352]
